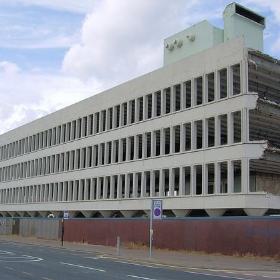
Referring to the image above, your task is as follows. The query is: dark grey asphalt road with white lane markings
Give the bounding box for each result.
[0,241,279,280]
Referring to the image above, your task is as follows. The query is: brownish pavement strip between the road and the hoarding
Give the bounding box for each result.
[0,235,280,272]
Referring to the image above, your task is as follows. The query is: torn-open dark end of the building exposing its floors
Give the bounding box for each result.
[248,50,280,198]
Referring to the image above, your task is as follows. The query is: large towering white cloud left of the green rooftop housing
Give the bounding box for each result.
[62,0,200,83]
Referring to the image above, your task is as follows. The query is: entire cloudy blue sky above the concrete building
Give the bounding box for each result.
[0,0,280,133]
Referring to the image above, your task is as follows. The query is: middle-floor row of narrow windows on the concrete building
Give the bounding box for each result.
[0,111,241,182]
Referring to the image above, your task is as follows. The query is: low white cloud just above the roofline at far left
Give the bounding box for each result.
[0,62,102,134]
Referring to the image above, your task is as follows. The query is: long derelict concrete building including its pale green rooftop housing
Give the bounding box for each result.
[0,3,280,217]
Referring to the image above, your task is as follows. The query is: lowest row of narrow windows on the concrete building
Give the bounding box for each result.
[0,160,242,203]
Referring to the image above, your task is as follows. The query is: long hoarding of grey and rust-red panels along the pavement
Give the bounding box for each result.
[4,217,280,256]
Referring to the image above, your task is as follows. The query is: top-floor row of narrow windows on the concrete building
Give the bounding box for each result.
[0,64,241,160]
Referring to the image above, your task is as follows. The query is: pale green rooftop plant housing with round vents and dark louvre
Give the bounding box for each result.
[164,2,265,66]
